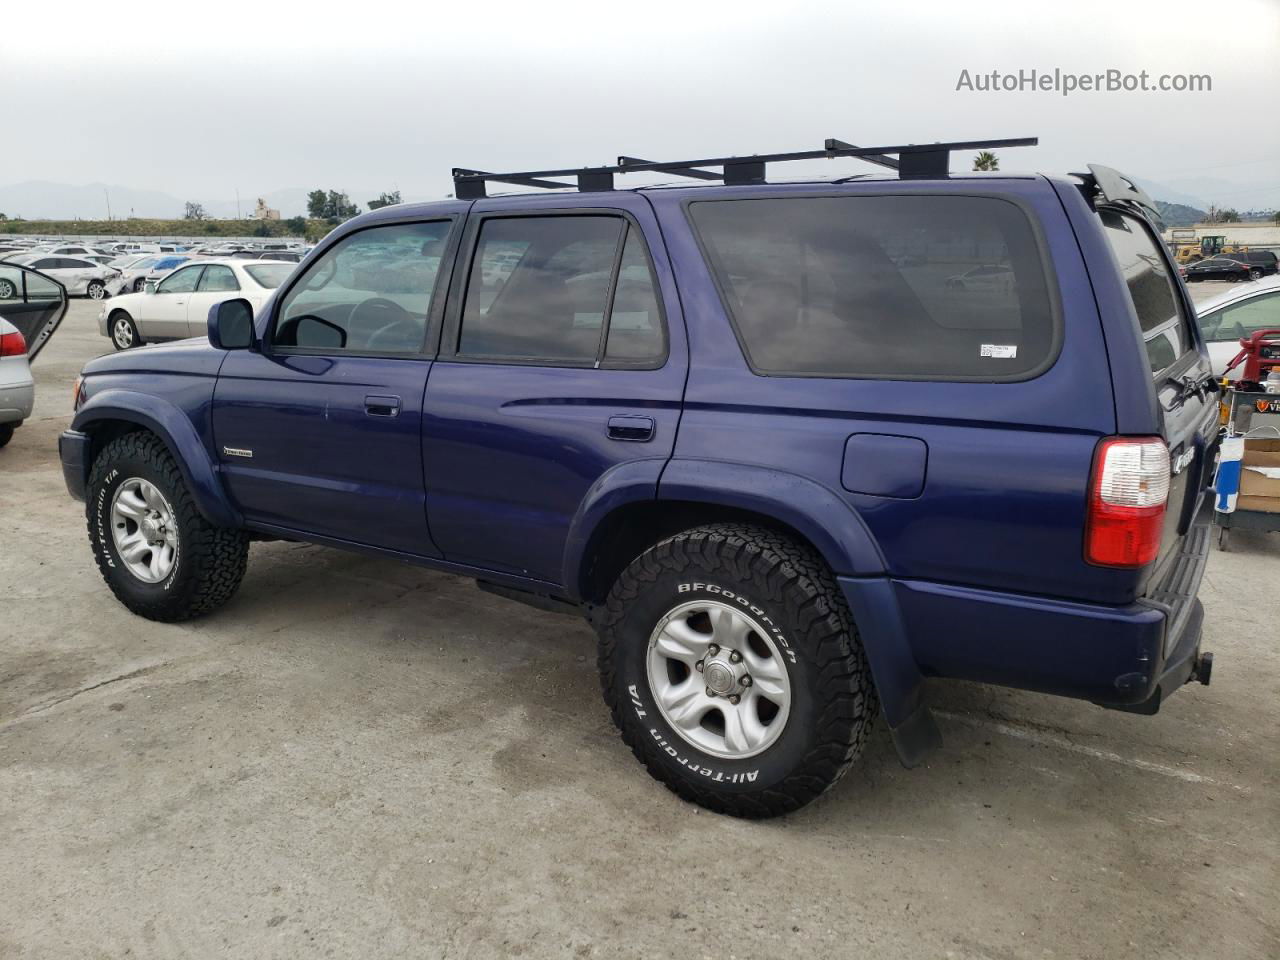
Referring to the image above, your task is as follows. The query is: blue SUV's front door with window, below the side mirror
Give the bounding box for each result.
[214,217,462,557]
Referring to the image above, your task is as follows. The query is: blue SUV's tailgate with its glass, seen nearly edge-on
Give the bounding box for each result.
[1098,207,1217,571]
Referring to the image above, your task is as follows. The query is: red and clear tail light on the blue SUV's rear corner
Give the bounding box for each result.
[1084,436,1170,568]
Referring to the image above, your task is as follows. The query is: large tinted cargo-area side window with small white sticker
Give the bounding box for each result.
[690,196,1056,380]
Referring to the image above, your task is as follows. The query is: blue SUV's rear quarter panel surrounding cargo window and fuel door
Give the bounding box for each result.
[649,178,1132,602]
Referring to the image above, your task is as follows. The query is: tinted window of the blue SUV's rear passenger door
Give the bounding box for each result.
[458,216,666,365]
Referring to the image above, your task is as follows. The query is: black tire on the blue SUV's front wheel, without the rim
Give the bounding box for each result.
[84,433,248,623]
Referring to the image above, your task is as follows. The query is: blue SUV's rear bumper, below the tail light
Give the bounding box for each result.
[841,522,1210,716]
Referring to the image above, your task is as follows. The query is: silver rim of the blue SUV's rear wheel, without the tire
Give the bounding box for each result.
[645,600,791,760]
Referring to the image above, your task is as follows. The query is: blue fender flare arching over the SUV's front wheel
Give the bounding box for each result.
[72,389,242,527]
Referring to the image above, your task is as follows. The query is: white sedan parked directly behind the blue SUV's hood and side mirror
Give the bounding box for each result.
[97,260,297,349]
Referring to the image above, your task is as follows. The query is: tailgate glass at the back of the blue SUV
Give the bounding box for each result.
[1098,210,1192,374]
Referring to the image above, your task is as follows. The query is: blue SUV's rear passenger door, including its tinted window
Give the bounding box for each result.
[422,193,687,584]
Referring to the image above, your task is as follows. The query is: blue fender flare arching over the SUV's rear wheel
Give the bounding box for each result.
[658,458,884,576]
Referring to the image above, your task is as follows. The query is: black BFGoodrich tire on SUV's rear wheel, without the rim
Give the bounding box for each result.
[595,524,879,818]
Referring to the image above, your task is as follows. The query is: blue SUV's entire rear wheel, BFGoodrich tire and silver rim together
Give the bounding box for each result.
[598,524,878,818]
